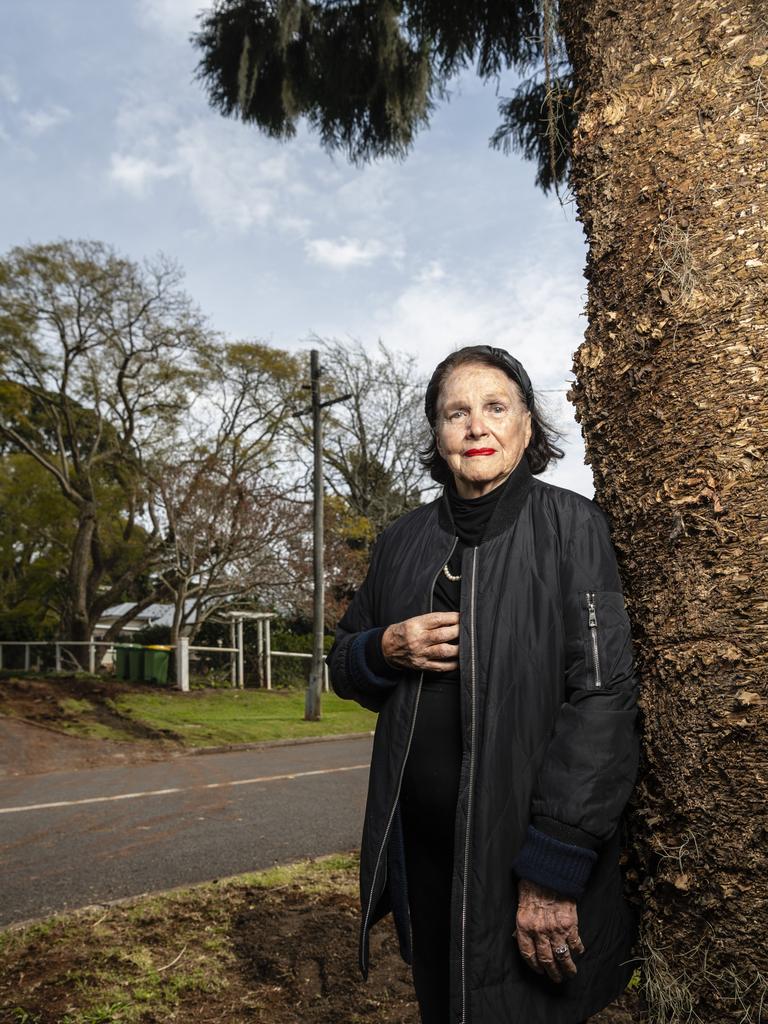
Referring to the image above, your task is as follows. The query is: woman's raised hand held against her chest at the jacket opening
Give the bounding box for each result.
[381,611,459,672]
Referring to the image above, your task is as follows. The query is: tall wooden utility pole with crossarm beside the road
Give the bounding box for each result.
[296,348,352,722]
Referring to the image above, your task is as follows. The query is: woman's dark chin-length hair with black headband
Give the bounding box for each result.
[419,345,564,484]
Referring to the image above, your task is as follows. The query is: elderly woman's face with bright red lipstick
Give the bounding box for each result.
[435,362,530,498]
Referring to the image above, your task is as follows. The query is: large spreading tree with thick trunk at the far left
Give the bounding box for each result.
[0,242,212,641]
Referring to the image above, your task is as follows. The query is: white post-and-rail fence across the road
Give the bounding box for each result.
[0,631,331,692]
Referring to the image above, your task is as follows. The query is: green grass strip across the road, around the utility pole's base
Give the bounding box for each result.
[115,690,376,746]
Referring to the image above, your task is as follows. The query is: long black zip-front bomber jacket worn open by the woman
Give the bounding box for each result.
[328,459,638,1024]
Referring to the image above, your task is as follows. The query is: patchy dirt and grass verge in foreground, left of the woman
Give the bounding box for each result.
[0,870,418,1024]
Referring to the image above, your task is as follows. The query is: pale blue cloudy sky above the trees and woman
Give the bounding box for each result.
[0,0,592,496]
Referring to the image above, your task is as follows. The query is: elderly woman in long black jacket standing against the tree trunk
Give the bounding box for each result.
[329,345,637,1024]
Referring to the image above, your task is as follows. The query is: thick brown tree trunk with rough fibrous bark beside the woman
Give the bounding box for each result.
[561,0,768,1024]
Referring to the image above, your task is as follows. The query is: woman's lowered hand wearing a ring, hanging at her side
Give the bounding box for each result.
[516,879,584,982]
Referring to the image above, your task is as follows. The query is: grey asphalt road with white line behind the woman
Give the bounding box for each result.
[0,737,371,926]
